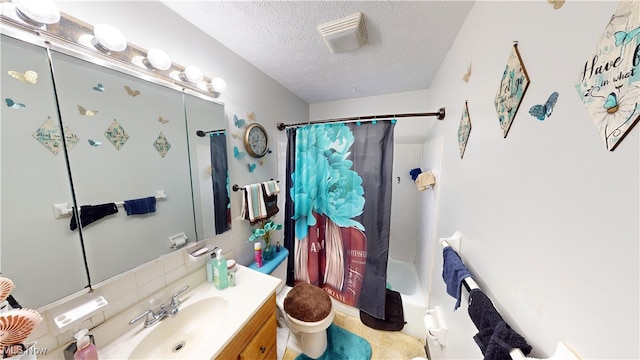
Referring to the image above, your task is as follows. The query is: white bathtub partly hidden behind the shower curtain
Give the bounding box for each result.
[333,259,427,339]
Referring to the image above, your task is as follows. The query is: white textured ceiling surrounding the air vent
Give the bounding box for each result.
[162,1,473,104]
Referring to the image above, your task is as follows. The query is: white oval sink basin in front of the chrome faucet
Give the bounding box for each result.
[129,296,229,359]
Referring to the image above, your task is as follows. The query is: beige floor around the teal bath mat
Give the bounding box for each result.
[283,312,426,360]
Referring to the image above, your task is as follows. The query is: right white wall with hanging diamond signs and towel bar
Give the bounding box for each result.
[429,1,640,359]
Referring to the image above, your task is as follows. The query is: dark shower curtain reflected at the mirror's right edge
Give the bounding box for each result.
[209,133,231,234]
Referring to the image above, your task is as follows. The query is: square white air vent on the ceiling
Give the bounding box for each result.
[318,13,369,53]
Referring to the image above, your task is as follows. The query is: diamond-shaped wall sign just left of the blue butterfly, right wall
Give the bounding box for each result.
[495,43,529,137]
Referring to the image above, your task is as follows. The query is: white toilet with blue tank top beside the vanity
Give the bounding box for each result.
[249,248,335,358]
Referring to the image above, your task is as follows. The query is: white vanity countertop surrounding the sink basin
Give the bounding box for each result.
[80,265,280,360]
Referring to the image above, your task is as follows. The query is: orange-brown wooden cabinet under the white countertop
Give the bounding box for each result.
[215,293,277,360]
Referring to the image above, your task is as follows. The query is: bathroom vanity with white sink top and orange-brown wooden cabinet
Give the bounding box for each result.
[43,265,280,360]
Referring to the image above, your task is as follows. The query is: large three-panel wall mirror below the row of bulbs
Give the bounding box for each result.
[0,19,230,308]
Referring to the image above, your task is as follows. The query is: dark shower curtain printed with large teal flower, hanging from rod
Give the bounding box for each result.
[285,121,395,319]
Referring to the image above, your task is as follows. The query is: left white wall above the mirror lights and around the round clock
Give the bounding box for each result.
[56,1,308,264]
